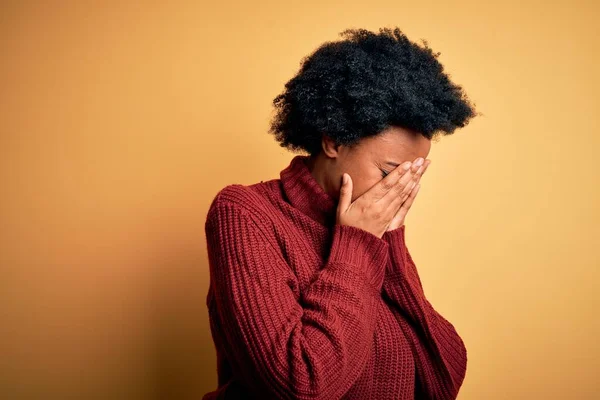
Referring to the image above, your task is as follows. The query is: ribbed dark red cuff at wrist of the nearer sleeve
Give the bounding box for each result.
[328,224,389,290]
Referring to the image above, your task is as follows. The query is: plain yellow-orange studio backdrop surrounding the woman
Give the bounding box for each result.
[0,1,600,400]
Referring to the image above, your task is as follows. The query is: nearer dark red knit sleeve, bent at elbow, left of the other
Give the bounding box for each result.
[205,202,389,399]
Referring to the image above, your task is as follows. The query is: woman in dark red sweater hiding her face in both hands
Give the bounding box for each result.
[204,28,475,400]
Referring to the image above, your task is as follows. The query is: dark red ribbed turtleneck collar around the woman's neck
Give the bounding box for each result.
[279,155,337,226]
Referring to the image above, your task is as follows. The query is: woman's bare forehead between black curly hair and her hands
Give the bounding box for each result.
[366,127,431,163]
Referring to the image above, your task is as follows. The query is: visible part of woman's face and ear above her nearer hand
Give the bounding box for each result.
[320,127,431,201]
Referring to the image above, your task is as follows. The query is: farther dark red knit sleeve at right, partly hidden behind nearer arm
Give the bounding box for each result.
[382,225,467,399]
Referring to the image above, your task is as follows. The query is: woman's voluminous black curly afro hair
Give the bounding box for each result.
[269,28,476,155]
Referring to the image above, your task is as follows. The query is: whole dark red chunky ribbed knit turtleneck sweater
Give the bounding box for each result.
[203,155,467,400]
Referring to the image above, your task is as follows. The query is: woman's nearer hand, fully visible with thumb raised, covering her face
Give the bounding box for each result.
[336,161,421,239]
